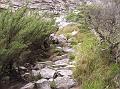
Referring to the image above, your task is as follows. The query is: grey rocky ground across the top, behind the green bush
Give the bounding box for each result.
[0,0,81,14]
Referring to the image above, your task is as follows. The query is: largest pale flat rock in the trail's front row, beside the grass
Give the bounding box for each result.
[54,76,76,89]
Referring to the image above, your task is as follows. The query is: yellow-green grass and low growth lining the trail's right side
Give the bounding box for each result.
[58,3,120,89]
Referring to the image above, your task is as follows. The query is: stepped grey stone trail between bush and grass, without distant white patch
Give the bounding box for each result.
[20,31,78,89]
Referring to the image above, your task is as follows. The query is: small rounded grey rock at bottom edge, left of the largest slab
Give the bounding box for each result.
[36,79,51,89]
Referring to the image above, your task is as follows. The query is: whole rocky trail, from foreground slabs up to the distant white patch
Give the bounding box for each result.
[10,16,79,89]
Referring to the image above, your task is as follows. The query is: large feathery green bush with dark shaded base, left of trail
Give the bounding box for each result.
[0,7,56,80]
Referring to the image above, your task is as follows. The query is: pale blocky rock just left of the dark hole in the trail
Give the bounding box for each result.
[40,67,55,79]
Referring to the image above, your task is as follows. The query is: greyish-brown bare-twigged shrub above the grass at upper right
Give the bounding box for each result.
[89,0,120,63]
